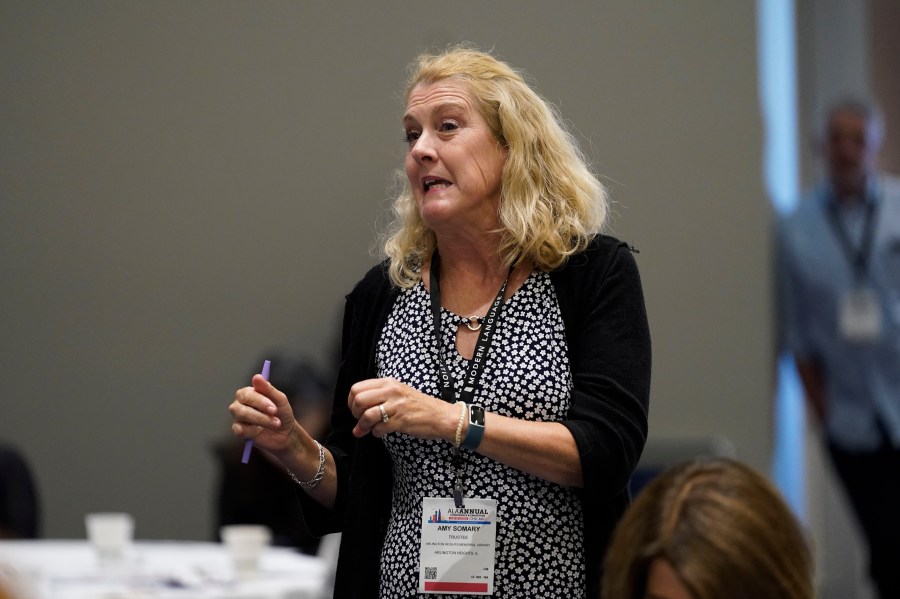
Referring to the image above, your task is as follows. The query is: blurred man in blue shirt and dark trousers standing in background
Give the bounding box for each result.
[777,99,900,599]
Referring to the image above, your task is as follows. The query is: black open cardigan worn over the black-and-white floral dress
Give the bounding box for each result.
[299,235,650,599]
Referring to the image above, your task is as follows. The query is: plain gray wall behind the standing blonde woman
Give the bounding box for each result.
[0,0,772,539]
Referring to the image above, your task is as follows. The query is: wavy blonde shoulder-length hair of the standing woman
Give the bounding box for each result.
[384,45,608,287]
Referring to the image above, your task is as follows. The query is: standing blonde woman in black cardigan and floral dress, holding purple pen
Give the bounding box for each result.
[230,47,650,598]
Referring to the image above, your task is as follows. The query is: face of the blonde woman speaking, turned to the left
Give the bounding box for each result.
[403,79,506,233]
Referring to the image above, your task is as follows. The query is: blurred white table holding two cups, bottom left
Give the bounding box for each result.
[0,540,328,599]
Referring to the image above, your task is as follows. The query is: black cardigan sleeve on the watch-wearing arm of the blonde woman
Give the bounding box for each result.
[556,237,651,505]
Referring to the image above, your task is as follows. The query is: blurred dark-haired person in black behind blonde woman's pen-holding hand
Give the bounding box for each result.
[214,352,331,555]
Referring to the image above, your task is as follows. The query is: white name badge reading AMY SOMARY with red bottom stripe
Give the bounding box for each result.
[419,497,497,595]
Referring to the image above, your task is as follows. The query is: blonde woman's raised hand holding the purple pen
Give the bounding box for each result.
[228,374,297,457]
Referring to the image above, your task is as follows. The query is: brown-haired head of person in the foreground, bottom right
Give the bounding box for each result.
[603,459,815,599]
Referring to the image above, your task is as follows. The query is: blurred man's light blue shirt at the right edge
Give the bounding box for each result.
[777,175,900,451]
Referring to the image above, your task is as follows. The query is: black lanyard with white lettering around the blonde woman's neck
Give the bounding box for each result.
[430,250,513,508]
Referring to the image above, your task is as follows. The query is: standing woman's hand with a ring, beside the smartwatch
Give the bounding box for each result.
[347,378,460,442]
